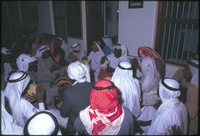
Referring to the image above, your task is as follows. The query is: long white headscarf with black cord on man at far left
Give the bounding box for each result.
[4,71,30,126]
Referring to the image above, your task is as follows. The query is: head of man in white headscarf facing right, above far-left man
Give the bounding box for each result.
[16,54,37,72]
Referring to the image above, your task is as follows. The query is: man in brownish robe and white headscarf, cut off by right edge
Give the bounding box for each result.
[173,60,199,135]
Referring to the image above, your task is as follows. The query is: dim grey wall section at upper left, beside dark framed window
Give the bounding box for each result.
[38,1,55,34]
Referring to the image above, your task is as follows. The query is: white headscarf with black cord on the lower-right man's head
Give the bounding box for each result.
[159,78,181,102]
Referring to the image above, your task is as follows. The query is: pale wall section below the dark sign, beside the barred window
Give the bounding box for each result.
[118,1,158,56]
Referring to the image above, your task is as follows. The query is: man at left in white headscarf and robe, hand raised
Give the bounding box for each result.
[4,71,45,127]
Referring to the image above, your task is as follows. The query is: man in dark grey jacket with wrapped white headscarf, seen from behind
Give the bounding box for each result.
[60,61,94,135]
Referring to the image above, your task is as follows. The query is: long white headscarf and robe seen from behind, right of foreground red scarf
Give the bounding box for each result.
[111,61,141,117]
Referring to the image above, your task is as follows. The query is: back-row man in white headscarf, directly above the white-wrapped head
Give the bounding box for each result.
[69,42,87,62]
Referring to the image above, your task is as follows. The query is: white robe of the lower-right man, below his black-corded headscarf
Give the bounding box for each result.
[143,98,188,135]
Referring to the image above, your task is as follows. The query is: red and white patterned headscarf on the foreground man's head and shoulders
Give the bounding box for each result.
[80,79,124,135]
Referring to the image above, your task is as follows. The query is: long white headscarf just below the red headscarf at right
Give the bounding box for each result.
[138,57,160,93]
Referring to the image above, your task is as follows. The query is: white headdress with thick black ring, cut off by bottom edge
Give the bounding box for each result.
[24,111,59,135]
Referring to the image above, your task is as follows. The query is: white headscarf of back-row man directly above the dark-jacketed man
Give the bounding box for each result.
[71,42,86,61]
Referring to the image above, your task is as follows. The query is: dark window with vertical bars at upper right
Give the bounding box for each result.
[155,1,199,64]
